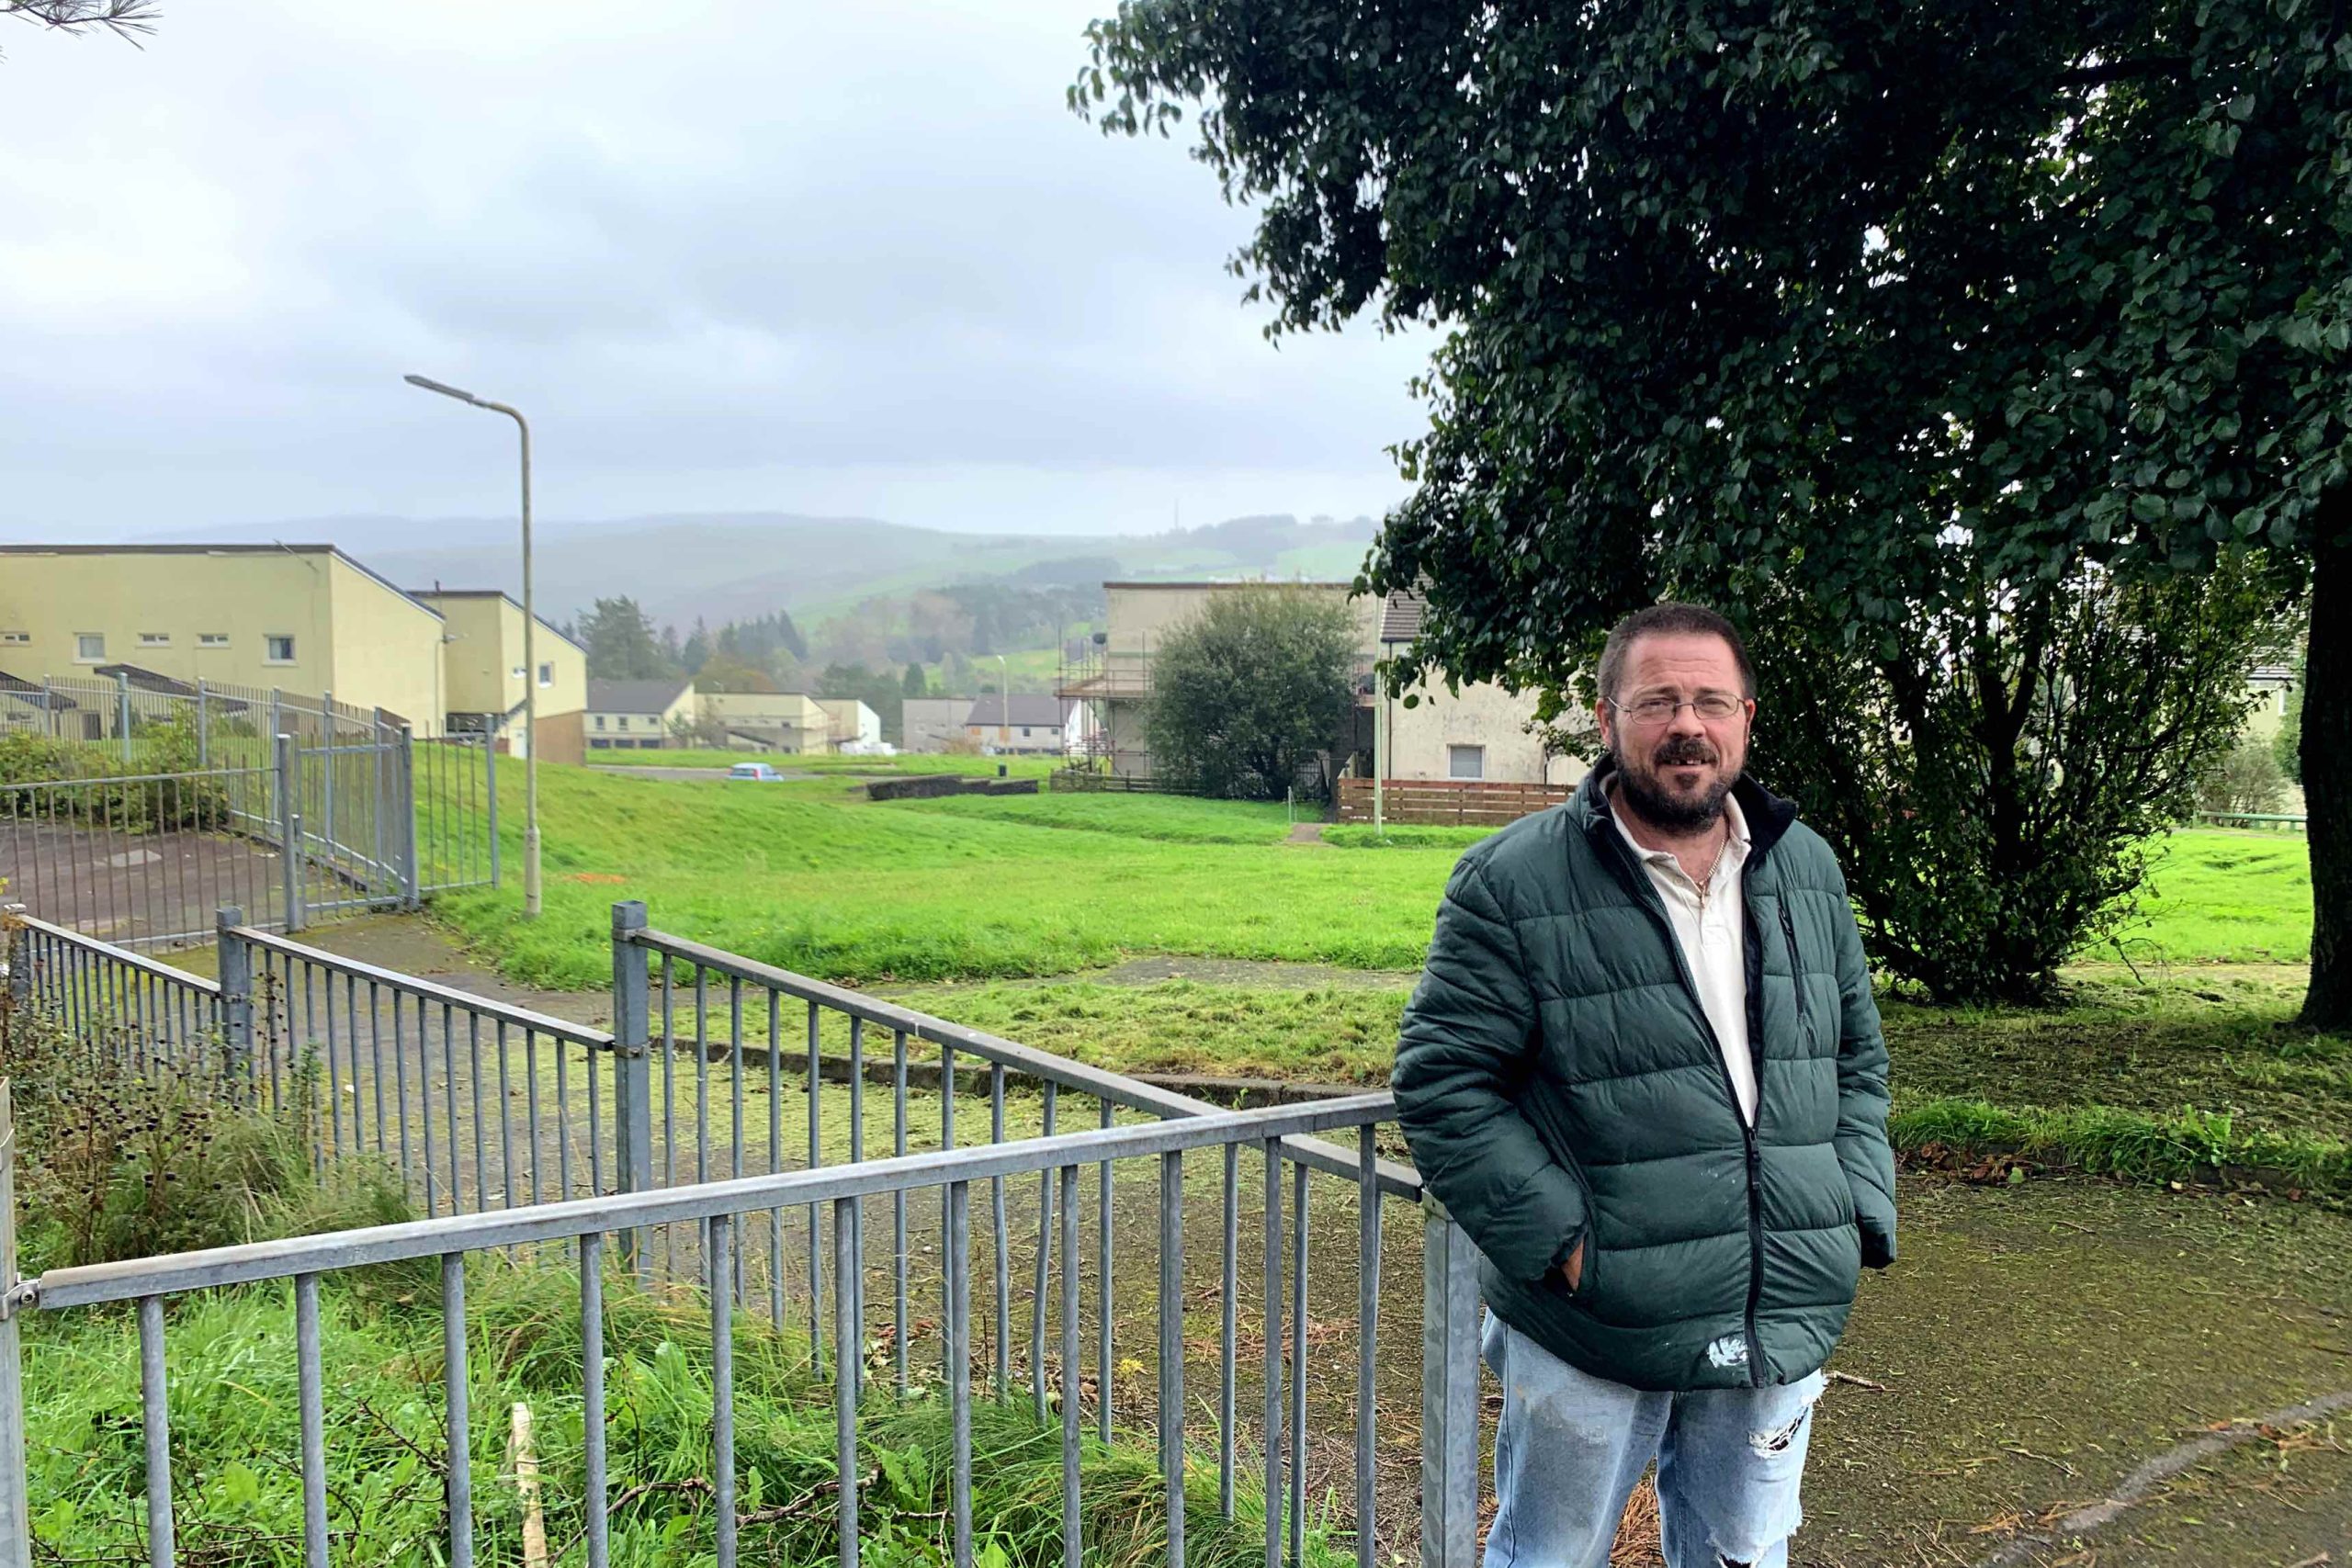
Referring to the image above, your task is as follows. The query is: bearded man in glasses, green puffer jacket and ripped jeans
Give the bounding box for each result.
[1395,604,1895,1568]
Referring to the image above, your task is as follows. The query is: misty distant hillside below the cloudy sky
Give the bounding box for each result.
[110,513,1376,627]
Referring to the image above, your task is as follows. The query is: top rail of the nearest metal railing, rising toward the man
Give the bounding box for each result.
[26,1093,1397,1307]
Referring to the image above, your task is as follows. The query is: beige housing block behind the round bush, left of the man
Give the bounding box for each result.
[1061,581,1585,799]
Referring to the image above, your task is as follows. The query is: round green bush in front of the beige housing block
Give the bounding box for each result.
[1143,585,1355,799]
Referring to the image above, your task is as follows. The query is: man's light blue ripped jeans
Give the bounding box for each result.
[1484,1312,1823,1568]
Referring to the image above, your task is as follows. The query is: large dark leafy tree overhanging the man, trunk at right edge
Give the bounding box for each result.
[1072,0,2352,1006]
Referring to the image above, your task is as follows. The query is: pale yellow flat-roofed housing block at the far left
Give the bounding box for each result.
[0,543,585,755]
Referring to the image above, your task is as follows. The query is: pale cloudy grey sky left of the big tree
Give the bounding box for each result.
[0,0,1428,538]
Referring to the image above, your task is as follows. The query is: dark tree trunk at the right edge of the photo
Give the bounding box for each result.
[2302,505,2352,1030]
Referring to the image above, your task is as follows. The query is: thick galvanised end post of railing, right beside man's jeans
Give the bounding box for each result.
[1420,1197,1479,1568]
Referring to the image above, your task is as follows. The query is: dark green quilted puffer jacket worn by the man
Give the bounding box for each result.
[1393,761,1895,1389]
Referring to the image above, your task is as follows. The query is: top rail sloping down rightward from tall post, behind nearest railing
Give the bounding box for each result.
[614,926,1420,1201]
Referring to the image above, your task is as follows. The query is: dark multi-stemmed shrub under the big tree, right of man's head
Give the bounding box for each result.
[1743,567,2272,1001]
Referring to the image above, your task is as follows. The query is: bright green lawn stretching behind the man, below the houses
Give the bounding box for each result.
[435,752,2310,987]
